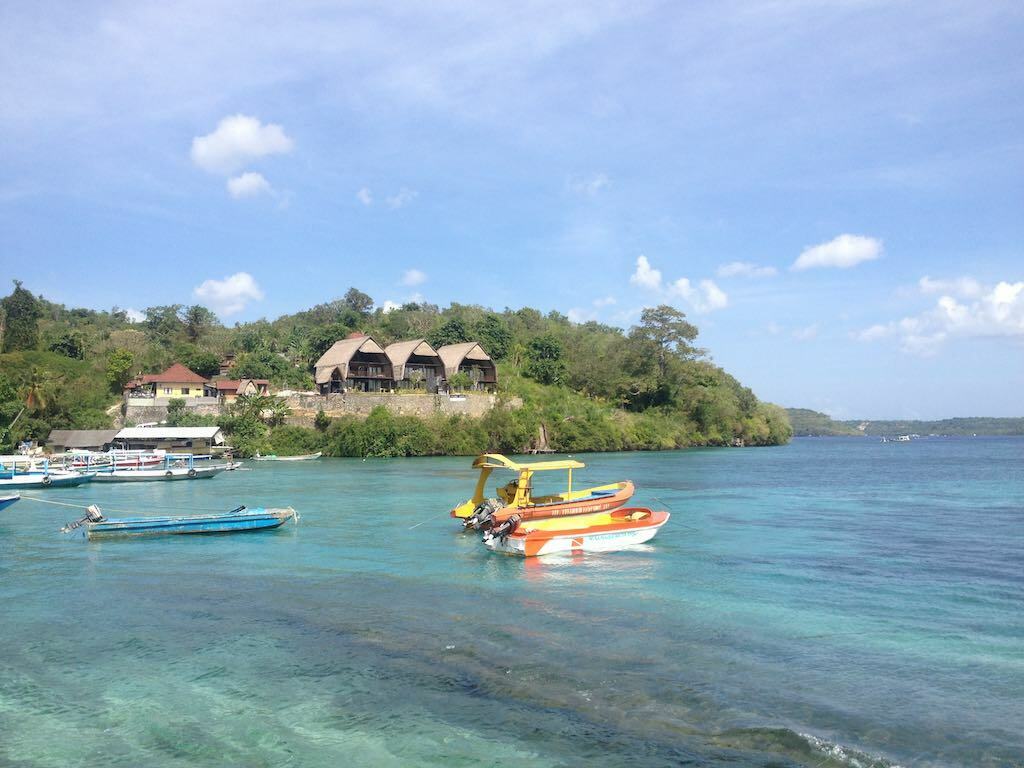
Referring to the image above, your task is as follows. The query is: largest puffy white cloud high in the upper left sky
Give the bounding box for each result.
[191,115,295,175]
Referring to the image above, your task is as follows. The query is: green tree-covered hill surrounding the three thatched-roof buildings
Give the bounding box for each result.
[0,283,792,456]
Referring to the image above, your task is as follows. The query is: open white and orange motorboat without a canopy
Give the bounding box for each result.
[483,507,671,557]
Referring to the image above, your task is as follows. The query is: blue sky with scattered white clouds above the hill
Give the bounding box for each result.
[0,0,1024,419]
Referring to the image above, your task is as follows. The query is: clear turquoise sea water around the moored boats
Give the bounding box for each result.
[0,438,1024,767]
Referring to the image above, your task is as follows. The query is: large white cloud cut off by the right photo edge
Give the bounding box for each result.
[853,281,1024,355]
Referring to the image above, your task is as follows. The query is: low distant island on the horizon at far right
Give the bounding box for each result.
[785,408,1024,437]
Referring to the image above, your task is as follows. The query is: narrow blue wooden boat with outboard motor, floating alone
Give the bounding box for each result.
[60,505,298,539]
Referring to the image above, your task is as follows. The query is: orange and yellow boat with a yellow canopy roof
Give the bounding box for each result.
[452,454,634,529]
